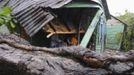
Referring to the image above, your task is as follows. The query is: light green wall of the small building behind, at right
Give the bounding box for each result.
[106,23,124,49]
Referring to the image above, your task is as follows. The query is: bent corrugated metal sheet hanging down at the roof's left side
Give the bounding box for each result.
[15,7,54,36]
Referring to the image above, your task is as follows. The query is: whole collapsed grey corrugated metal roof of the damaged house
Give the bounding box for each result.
[0,0,108,36]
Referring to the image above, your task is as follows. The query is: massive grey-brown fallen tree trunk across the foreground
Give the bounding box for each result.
[0,35,134,75]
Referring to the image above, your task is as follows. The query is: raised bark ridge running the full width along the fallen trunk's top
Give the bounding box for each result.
[0,34,134,67]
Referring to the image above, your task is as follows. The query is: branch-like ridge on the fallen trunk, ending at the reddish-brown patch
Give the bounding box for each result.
[0,38,104,67]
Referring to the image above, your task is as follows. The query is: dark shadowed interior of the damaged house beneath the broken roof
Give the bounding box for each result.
[30,8,97,47]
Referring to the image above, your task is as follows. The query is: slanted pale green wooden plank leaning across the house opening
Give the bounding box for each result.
[80,10,103,47]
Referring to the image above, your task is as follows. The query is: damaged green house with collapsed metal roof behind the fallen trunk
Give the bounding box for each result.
[0,0,110,52]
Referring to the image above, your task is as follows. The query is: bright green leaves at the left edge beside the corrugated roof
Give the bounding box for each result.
[0,6,16,32]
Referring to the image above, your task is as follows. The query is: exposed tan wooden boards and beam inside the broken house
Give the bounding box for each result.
[43,22,85,37]
